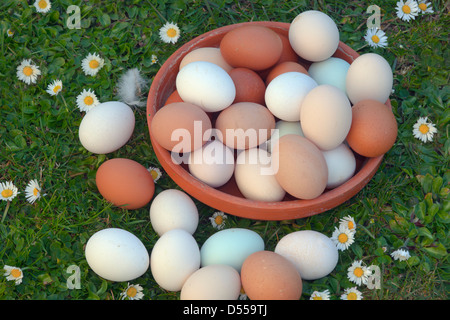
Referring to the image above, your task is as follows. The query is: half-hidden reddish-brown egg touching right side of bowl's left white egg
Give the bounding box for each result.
[228,68,266,104]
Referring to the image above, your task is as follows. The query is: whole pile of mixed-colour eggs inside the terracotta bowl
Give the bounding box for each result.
[150,10,397,202]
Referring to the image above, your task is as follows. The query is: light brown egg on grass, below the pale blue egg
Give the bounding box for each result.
[241,251,303,300]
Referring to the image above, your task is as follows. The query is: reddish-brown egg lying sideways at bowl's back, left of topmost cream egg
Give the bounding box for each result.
[220,25,283,71]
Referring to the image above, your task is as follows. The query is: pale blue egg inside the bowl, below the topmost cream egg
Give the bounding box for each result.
[308,57,350,94]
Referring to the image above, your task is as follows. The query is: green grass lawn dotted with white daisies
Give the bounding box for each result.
[0,0,450,300]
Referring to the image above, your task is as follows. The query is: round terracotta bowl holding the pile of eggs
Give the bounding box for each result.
[147,21,391,220]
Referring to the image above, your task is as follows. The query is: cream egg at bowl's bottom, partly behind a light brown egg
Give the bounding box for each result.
[234,148,286,201]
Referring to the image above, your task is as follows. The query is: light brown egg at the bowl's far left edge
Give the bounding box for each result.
[150,102,212,153]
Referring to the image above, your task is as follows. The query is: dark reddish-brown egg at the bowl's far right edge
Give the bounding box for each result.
[346,100,398,157]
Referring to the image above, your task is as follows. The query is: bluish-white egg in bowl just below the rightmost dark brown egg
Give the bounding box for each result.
[322,143,356,189]
